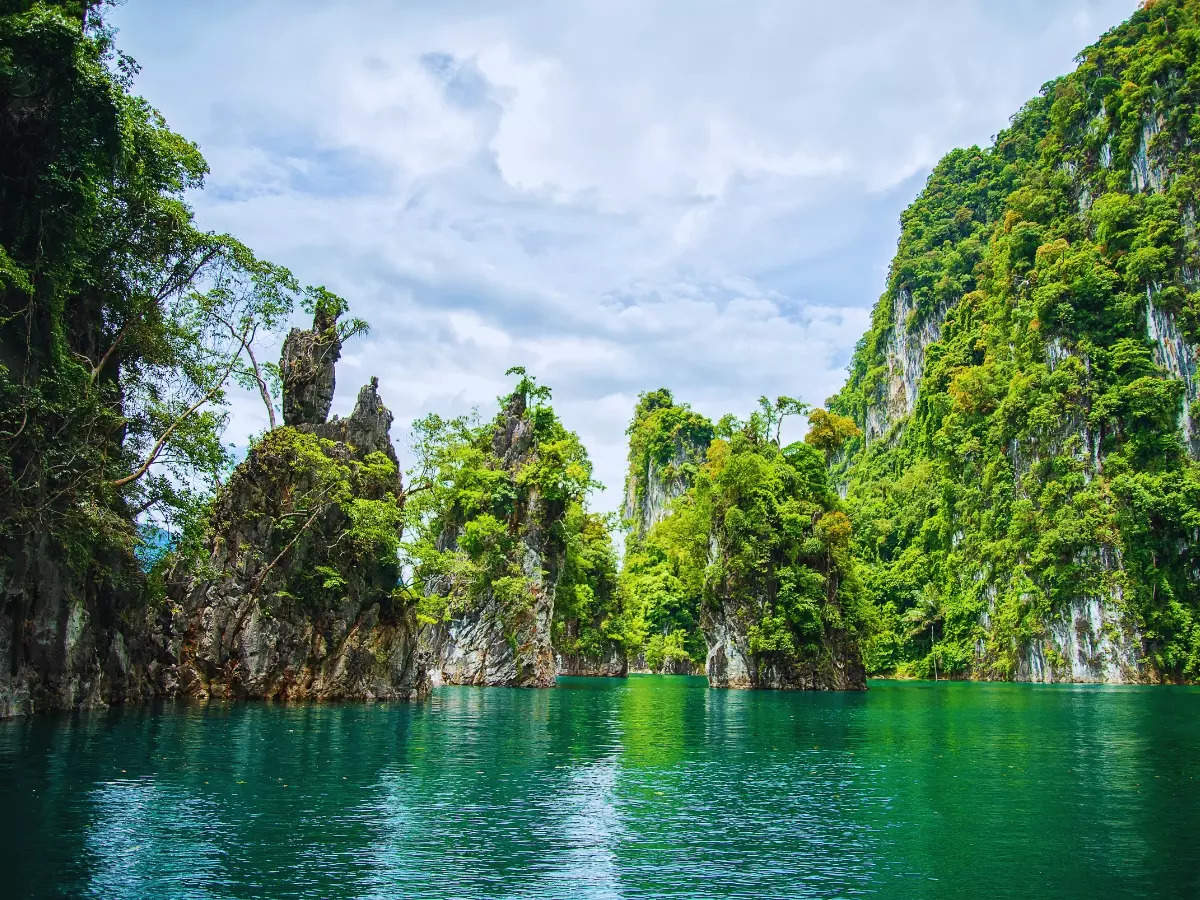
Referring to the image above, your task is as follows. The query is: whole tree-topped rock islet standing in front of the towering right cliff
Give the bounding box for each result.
[696,434,866,690]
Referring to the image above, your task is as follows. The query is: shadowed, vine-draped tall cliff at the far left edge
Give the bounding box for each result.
[0,10,166,718]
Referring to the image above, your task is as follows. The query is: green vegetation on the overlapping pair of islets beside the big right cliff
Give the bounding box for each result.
[619,389,869,671]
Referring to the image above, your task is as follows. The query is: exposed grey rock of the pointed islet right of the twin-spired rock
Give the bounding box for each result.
[424,392,566,688]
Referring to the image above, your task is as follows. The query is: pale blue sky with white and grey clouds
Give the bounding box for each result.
[108,0,1134,510]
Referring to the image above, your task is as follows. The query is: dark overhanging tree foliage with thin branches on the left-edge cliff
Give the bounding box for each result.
[0,2,344,607]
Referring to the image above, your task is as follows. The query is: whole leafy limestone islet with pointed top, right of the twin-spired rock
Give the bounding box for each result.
[415,378,590,688]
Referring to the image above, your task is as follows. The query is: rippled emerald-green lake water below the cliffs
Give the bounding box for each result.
[0,676,1200,898]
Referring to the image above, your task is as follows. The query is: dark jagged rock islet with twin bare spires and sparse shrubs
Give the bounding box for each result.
[163,322,430,700]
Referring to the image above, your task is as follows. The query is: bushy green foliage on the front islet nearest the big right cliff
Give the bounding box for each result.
[619,397,860,670]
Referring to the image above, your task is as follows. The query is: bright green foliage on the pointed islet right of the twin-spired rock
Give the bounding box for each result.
[403,367,597,641]
